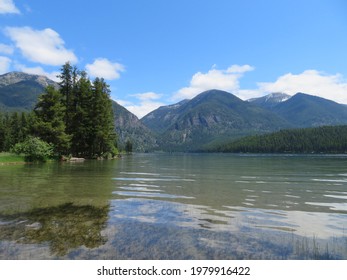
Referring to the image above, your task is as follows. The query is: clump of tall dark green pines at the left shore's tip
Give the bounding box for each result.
[26,63,116,158]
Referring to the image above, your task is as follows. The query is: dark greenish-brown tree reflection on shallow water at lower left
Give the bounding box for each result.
[0,203,109,256]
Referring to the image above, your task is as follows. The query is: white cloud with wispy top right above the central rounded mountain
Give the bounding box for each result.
[173,65,254,100]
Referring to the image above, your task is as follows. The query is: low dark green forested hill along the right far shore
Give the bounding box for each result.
[213,125,347,153]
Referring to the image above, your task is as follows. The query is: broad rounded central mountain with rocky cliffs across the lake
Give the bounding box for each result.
[143,90,290,151]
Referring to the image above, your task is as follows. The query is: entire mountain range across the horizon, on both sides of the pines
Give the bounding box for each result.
[0,72,347,152]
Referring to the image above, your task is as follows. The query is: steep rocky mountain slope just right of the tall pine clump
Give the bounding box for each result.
[112,101,158,152]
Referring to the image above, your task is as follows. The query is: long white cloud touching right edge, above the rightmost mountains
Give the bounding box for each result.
[257,70,347,104]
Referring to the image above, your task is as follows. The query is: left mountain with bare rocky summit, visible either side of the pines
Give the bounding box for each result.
[0,72,157,152]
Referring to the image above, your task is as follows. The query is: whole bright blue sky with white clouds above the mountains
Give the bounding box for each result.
[0,0,347,118]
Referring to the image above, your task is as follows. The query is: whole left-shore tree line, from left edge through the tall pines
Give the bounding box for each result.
[0,63,118,161]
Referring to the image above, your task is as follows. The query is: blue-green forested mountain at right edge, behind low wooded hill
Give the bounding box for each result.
[271,93,347,127]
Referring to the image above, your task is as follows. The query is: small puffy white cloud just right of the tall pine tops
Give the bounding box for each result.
[86,58,125,80]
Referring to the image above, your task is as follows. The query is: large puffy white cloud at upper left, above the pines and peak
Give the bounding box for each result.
[5,26,77,66]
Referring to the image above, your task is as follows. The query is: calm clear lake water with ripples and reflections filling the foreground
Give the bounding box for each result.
[0,154,347,259]
